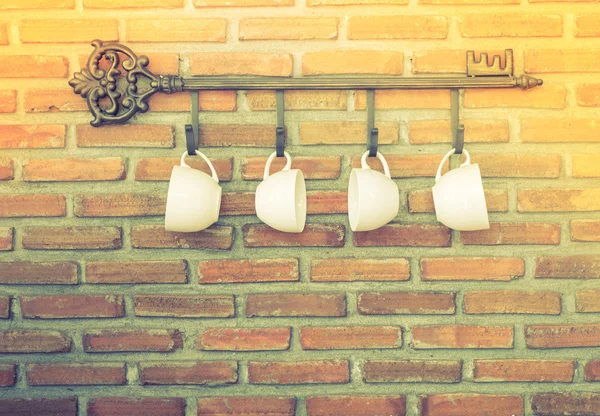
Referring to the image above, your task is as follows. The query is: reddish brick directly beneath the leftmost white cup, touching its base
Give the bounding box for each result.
[131,225,233,250]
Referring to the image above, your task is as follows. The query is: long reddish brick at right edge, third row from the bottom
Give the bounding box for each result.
[525,324,600,348]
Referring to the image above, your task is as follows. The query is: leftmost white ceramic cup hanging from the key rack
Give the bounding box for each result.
[165,152,222,233]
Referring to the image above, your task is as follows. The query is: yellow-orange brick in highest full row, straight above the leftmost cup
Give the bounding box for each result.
[126,18,227,43]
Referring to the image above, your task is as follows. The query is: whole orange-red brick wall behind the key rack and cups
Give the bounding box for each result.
[0,0,600,416]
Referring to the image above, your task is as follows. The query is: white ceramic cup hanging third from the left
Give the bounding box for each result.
[348,151,400,231]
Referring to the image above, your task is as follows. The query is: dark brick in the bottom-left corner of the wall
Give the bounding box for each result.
[0,396,77,416]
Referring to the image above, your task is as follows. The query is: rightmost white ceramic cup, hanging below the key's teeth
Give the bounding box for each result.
[432,149,490,231]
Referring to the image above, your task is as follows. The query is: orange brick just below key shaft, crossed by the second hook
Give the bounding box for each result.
[246,90,346,111]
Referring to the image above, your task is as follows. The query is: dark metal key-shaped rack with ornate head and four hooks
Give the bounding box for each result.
[69,40,543,156]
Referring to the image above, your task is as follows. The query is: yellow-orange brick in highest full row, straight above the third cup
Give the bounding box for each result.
[348,15,448,39]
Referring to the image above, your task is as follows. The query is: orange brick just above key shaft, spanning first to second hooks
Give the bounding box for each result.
[189,52,293,77]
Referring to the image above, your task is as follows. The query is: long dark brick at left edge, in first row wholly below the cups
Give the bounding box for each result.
[0,262,77,285]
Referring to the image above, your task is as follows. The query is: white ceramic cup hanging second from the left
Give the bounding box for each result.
[255,152,306,233]
